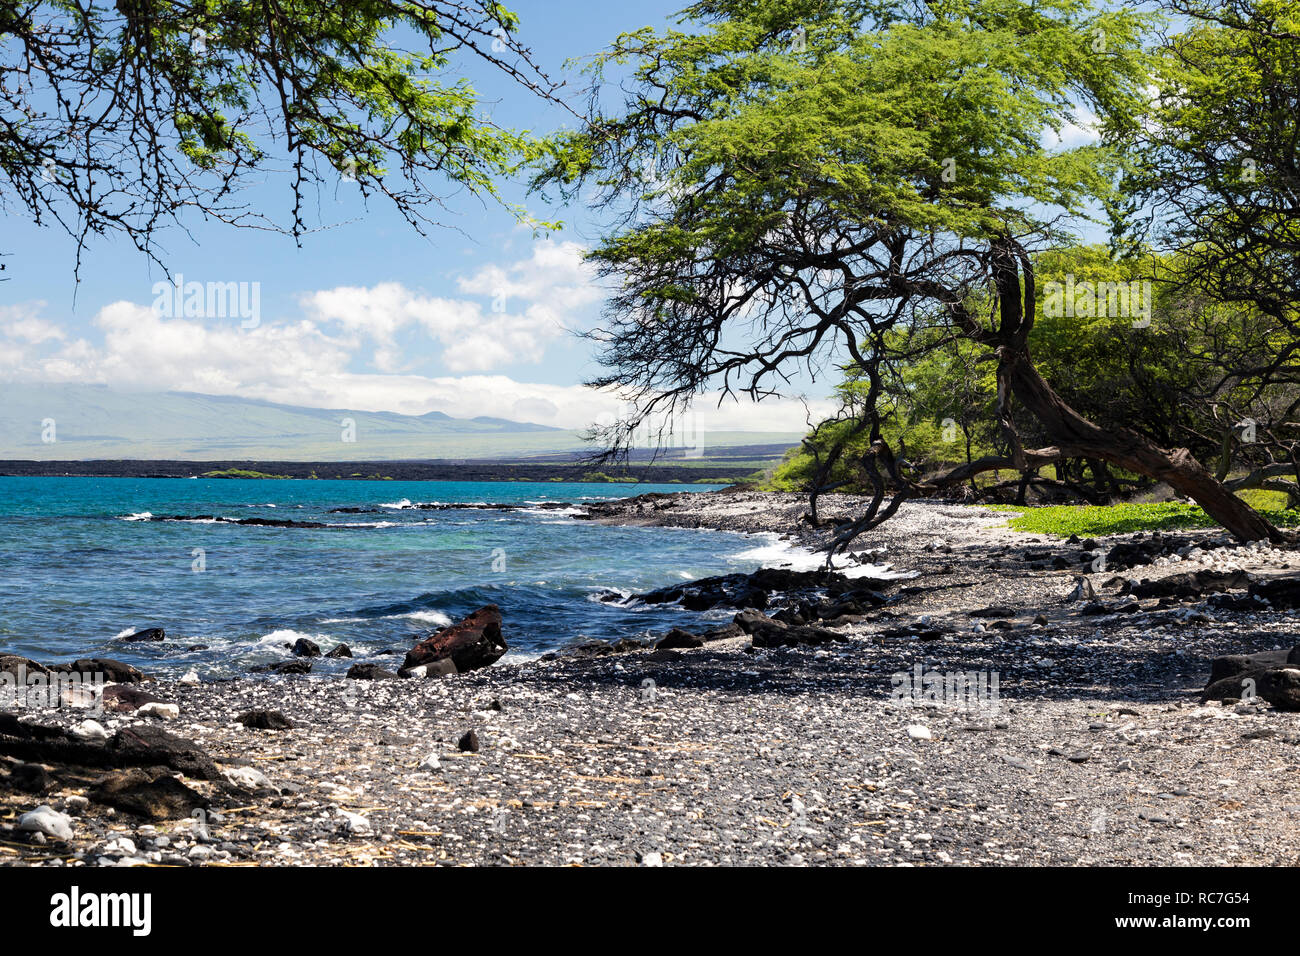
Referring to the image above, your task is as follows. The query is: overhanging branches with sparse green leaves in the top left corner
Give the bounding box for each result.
[0,0,556,274]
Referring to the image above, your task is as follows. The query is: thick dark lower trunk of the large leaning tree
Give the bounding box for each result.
[1000,346,1287,544]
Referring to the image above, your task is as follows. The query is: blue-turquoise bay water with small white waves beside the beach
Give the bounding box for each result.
[0,477,780,675]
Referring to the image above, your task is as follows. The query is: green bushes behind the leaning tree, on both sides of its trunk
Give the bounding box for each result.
[771,235,1297,503]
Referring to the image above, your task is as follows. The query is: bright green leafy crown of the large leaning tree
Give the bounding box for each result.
[538,0,1151,257]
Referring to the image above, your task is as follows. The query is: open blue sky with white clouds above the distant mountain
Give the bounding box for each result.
[0,0,1107,431]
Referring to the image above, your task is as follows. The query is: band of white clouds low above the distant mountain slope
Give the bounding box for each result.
[0,242,829,432]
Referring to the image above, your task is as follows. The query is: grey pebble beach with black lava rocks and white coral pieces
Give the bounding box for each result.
[0,492,1300,866]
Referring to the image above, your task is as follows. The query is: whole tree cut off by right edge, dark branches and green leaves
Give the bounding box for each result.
[1118,0,1300,515]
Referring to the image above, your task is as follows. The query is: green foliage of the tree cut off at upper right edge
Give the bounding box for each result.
[1123,0,1300,324]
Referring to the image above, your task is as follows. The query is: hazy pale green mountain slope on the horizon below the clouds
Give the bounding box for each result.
[0,384,798,462]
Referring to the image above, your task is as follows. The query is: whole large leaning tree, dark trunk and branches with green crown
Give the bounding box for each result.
[536,0,1282,554]
